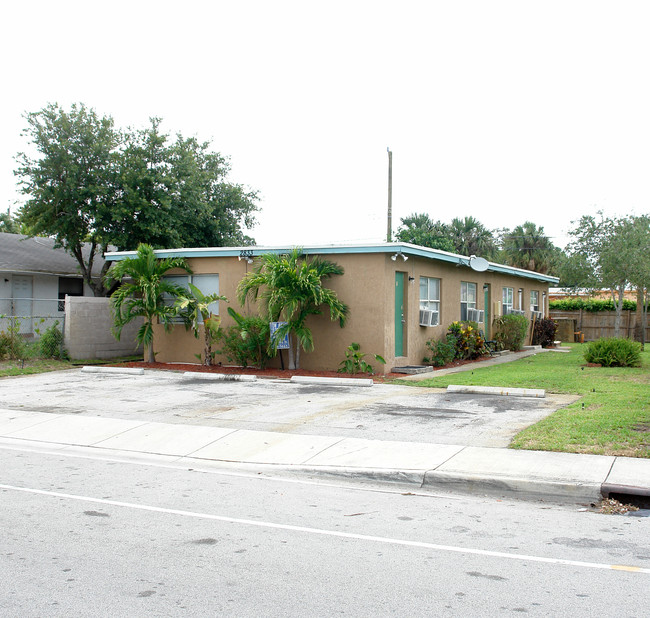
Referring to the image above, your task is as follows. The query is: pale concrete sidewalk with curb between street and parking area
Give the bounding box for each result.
[0,410,650,503]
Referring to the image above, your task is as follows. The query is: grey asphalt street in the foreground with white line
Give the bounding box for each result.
[0,440,650,618]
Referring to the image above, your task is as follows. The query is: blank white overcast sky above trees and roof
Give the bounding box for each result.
[0,0,650,246]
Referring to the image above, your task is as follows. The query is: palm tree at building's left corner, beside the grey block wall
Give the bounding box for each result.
[106,244,192,363]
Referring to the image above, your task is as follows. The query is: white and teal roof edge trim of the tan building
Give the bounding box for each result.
[104,242,559,285]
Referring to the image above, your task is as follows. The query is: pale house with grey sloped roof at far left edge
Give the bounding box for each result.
[0,233,104,334]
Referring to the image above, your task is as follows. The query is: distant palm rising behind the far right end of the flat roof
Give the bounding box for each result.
[503,221,556,273]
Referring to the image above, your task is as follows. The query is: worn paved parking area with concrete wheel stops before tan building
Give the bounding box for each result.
[0,370,575,447]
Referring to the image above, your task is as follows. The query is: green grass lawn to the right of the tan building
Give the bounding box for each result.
[404,344,650,458]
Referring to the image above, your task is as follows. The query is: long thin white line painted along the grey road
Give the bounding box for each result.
[0,484,650,574]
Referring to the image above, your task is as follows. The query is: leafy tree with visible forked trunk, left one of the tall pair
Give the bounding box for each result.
[15,103,121,296]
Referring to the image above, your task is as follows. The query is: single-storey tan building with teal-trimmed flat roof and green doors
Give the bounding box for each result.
[105,243,558,371]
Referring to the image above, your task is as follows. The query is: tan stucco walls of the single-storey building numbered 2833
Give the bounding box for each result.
[155,253,548,372]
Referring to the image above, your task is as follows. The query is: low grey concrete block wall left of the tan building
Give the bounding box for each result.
[63,296,142,359]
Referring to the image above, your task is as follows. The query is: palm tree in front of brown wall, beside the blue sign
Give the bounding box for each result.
[237,248,349,369]
